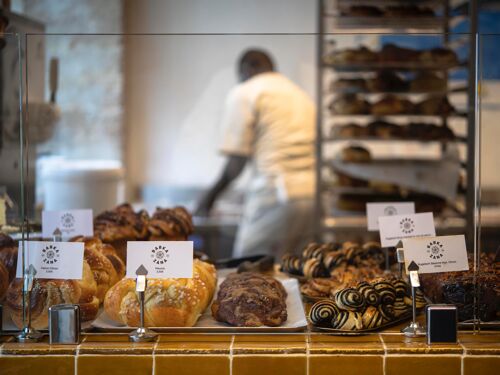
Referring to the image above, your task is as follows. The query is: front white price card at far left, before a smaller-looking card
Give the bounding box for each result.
[16,241,84,280]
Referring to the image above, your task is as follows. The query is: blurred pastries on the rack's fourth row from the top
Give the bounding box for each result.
[328,94,456,116]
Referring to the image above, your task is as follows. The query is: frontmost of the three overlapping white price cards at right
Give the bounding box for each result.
[403,235,469,273]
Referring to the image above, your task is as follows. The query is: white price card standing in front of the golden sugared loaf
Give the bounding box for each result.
[127,241,193,279]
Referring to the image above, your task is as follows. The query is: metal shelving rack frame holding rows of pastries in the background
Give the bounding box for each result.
[316,0,477,249]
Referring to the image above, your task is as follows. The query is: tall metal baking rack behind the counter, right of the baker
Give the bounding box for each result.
[316,0,477,249]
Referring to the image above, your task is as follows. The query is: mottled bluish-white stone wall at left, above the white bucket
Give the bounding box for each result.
[21,0,123,160]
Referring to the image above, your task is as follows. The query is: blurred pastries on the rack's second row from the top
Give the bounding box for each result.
[323,43,458,66]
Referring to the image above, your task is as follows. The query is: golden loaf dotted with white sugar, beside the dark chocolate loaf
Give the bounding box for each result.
[104,259,217,327]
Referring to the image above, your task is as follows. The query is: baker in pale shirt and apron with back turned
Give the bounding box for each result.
[196,49,315,257]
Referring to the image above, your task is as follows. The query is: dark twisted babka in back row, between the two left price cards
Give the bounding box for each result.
[94,203,149,262]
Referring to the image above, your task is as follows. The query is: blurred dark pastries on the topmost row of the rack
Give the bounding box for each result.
[340,4,435,18]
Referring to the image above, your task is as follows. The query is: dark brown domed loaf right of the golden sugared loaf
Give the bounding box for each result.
[212,272,287,327]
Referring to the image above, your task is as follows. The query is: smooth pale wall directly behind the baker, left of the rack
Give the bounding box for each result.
[125,0,316,200]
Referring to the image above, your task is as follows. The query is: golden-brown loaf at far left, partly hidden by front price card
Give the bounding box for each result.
[5,261,99,329]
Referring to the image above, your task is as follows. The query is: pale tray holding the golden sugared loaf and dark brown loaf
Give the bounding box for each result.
[92,278,307,333]
